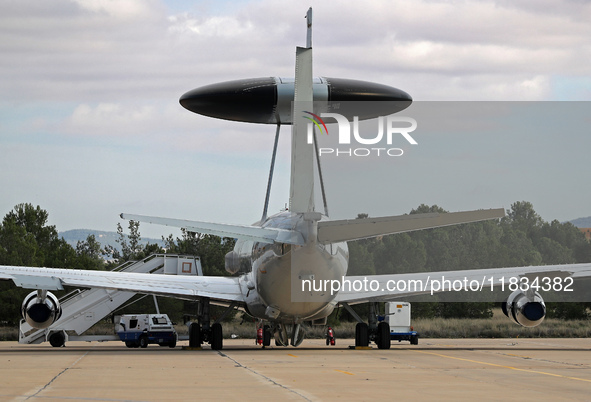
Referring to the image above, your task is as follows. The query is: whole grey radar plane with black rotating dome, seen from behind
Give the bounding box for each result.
[0,8,591,350]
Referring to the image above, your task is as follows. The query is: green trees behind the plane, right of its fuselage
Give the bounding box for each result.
[348,201,591,319]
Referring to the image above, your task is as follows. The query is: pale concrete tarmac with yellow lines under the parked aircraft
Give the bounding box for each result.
[0,338,591,401]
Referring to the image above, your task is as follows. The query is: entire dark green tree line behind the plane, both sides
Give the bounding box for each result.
[0,201,591,324]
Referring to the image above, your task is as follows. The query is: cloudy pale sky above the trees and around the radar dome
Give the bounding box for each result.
[0,0,591,238]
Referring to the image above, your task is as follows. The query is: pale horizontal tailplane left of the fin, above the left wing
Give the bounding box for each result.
[121,214,304,245]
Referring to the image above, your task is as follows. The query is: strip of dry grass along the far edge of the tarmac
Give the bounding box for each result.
[0,310,591,341]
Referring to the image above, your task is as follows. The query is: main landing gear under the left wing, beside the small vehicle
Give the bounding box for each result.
[189,297,235,350]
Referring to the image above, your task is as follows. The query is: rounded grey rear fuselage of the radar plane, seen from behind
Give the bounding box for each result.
[226,211,349,323]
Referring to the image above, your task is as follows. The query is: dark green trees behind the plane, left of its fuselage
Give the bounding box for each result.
[0,203,234,325]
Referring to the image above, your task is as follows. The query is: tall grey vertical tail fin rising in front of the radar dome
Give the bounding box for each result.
[289,10,314,212]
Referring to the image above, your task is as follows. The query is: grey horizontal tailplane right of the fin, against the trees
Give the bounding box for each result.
[318,208,505,243]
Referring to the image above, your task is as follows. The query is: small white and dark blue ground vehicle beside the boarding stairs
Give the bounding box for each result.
[115,314,178,348]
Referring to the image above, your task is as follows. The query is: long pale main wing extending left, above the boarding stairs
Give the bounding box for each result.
[0,266,244,302]
